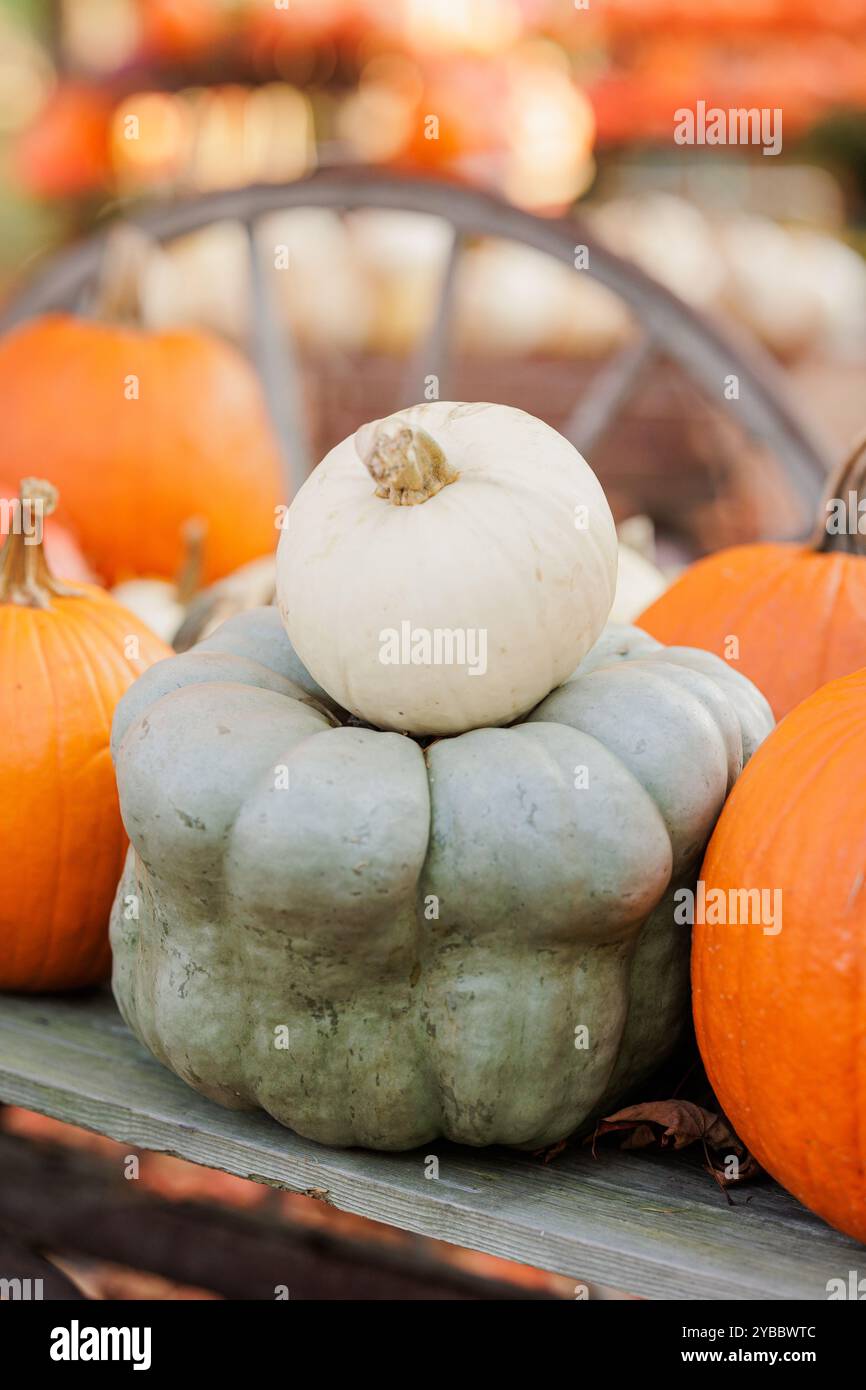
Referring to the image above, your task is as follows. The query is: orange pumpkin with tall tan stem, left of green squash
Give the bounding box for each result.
[0,478,171,990]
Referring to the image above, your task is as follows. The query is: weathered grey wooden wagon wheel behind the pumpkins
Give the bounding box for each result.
[0,168,831,530]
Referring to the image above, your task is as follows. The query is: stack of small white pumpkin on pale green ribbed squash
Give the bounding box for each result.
[104,402,773,1150]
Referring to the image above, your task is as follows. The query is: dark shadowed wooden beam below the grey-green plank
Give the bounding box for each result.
[0,1133,553,1302]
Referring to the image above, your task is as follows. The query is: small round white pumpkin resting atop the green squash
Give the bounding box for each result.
[277,402,617,734]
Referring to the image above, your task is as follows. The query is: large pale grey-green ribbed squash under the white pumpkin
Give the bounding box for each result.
[111,609,773,1150]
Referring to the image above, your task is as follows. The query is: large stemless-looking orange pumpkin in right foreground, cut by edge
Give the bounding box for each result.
[692,671,866,1241]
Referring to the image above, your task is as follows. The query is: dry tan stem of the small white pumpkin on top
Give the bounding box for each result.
[354,416,457,507]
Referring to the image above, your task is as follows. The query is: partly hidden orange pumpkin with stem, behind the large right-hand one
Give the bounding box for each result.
[638,442,866,719]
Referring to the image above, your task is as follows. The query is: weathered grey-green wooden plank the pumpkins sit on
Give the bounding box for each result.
[0,995,866,1300]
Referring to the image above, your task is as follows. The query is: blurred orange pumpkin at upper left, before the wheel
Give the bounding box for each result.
[0,314,281,585]
